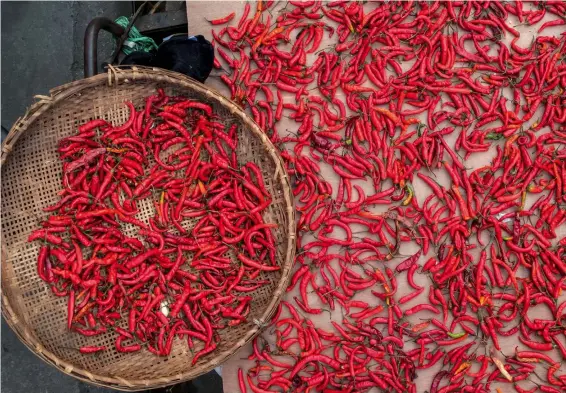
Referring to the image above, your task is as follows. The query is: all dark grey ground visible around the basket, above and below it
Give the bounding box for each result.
[0,1,222,393]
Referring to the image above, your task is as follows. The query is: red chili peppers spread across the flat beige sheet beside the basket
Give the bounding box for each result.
[210,1,566,393]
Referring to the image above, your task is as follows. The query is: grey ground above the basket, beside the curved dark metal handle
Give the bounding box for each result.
[1,1,131,129]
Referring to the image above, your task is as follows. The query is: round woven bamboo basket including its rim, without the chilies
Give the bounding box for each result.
[0,67,295,391]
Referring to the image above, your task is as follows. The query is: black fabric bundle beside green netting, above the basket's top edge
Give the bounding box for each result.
[121,35,214,82]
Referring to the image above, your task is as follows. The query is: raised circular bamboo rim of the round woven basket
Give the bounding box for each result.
[0,66,296,391]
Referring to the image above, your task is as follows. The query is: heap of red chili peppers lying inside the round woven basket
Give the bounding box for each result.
[29,90,279,364]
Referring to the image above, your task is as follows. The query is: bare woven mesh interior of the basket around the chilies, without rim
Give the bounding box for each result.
[1,73,290,386]
